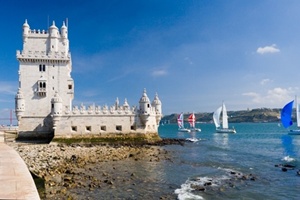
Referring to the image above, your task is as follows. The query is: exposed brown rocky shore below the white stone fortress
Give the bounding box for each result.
[8,140,175,199]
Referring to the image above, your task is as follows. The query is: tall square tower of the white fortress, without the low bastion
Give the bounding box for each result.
[16,20,74,136]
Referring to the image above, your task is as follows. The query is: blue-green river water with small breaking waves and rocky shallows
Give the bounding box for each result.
[78,123,300,200]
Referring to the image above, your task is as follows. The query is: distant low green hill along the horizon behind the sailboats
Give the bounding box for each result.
[161,108,288,123]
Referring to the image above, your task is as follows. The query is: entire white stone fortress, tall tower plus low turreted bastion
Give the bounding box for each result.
[15,20,162,138]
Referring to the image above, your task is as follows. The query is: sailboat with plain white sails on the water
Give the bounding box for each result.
[213,102,236,133]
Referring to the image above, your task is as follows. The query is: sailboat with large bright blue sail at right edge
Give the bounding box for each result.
[280,97,300,135]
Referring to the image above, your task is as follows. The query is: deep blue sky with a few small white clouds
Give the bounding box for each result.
[0,0,300,123]
